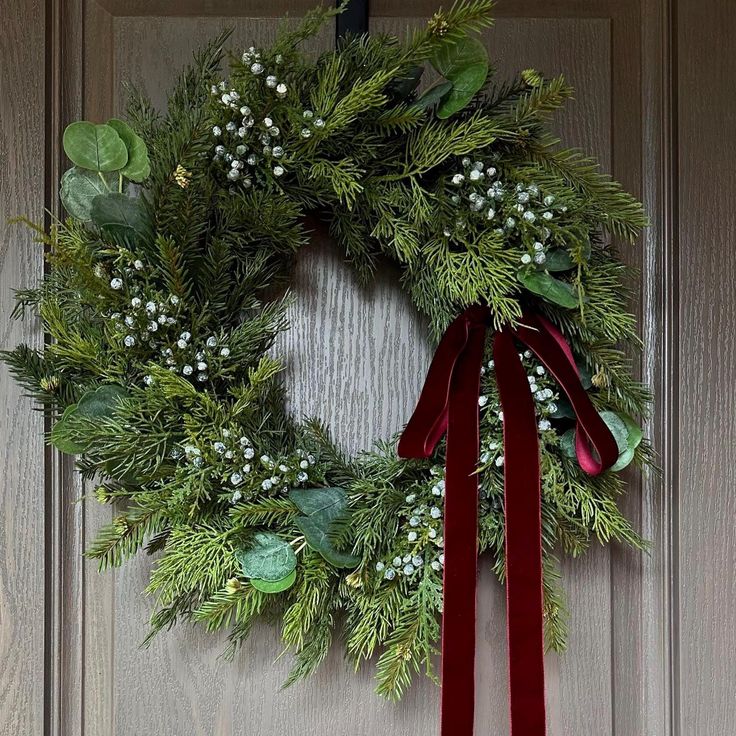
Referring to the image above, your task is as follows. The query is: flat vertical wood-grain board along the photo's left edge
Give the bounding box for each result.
[0,0,45,736]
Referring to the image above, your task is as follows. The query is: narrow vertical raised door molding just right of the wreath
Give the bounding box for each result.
[632,0,682,736]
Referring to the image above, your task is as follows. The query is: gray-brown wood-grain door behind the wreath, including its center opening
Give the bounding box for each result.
[0,0,736,736]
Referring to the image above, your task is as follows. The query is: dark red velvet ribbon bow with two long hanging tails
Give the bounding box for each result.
[398,306,618,736]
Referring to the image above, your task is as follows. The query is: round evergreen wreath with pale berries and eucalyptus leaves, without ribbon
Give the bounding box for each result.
[4,0,650,698]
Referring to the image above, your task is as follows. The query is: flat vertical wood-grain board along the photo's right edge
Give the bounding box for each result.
[675,0,736,736]
